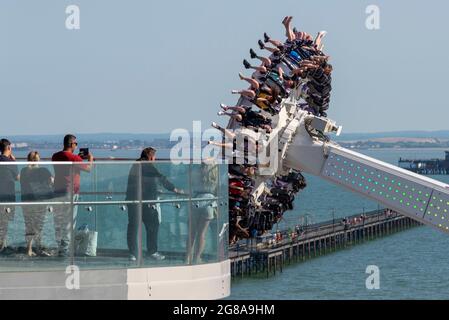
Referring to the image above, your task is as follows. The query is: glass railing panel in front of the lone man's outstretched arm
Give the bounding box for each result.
[141,162,190,266]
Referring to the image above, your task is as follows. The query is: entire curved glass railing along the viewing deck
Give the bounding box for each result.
[0,161,228,272]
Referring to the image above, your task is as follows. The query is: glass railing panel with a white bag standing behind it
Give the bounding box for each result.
[74,161,137,269]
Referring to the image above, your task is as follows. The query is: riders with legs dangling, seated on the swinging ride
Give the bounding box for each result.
[214,16,333,243]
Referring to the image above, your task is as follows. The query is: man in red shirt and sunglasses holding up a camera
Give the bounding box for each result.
[51,134,94,257]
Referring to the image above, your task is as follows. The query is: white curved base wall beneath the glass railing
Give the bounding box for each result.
[0,260,231,300]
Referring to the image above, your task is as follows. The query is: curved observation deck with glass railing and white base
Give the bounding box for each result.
[0,161,230,299]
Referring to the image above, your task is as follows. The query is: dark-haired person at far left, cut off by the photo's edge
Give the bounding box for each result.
[0,139,19,252]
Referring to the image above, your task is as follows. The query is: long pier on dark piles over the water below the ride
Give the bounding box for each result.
[229,209,422,278]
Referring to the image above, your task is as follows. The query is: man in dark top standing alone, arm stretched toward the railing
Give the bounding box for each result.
[125,147,183,261]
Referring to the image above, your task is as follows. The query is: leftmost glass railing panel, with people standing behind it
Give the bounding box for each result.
[0,162,73,271]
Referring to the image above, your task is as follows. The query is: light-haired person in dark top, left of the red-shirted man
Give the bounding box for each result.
[20,151,53,257]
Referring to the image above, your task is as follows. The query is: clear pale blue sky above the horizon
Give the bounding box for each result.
[0,0,449,135]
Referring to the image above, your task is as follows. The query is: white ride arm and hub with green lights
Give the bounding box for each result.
[228,86,449,232]
